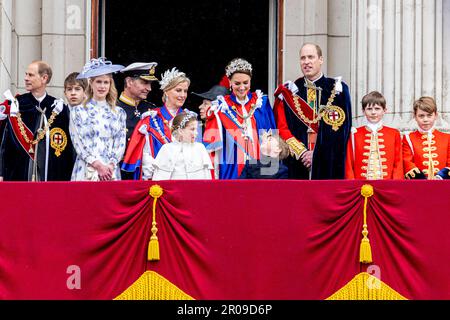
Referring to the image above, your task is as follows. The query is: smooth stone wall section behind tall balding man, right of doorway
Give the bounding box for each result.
[283,0,352,116]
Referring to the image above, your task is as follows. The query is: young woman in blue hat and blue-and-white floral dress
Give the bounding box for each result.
[69,58,126,181]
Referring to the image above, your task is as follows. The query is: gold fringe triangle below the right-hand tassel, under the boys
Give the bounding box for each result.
[326,272,408,300]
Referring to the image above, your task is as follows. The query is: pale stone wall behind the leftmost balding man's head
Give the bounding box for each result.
[0,0,90,97]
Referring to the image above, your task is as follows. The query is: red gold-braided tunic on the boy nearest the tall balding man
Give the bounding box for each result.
[345,126,403,180]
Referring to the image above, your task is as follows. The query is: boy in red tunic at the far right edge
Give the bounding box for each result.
[403,97,450,180]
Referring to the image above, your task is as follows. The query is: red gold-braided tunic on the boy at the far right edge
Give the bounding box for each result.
[402,129,450,179]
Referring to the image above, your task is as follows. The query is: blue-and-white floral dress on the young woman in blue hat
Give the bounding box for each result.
[69,100,126,181]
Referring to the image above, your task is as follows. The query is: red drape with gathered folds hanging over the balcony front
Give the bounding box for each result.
[0,180,450,300]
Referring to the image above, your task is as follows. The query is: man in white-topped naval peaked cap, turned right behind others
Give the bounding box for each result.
[117,62,158,180]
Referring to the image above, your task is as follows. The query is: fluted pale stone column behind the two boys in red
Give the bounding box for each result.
[352,0,450,131]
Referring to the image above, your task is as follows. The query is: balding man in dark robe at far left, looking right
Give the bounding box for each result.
[0,61,75,181]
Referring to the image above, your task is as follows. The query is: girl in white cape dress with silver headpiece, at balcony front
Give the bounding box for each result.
[142,110,213,180]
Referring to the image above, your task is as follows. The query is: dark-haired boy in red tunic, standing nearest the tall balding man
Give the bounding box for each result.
[345,91,403,180]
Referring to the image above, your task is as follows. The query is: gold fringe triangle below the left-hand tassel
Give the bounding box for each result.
[114,271,195,300]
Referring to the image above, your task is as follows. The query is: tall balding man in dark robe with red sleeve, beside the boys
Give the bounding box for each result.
[274,43,352,179]
